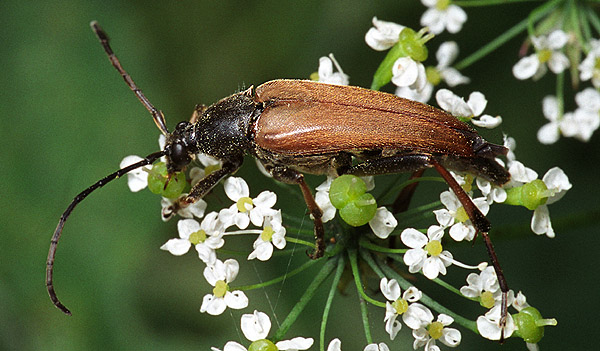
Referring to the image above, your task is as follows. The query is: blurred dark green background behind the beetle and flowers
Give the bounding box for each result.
[0,0,600,350]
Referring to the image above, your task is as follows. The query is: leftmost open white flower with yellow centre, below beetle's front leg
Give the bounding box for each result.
[160,212,225,265]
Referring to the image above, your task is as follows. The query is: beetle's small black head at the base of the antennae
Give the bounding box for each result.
[164,122,198,174]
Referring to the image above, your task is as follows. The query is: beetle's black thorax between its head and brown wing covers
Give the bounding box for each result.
[194,88,258,160]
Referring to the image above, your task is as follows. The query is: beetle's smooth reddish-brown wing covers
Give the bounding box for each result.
[253,80,474,157]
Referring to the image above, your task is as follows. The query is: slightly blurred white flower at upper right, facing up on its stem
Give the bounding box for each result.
[513,30,569,80]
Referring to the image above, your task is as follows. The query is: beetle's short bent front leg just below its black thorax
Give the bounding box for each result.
[162,158,243,219]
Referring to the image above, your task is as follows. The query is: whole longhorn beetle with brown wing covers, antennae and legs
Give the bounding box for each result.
[46,21,510,340]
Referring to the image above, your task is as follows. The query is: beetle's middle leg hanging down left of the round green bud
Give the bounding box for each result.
[265,166,325,260]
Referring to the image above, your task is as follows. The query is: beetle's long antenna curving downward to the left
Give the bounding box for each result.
[46,151,165,316]
